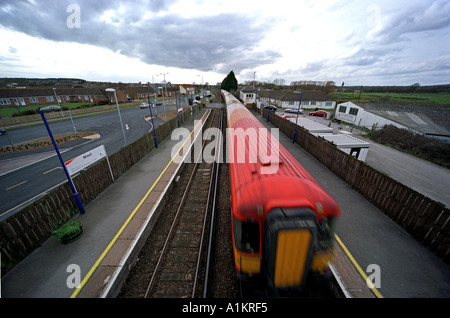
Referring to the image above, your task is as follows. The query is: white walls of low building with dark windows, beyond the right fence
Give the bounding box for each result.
[335,102,407,128]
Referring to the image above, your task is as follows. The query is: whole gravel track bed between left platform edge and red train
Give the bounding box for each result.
[119,110,222,298]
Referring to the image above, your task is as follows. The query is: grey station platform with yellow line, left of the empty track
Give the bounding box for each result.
[1,108,207,298]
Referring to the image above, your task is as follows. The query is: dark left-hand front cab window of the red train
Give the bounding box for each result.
[233,217,259,253]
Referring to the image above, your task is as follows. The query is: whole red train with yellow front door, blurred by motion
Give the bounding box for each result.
[222,90,340,296]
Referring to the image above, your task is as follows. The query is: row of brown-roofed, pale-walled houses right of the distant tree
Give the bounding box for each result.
[258,90,336,109]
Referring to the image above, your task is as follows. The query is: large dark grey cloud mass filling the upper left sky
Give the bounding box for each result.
[0,0,281,73]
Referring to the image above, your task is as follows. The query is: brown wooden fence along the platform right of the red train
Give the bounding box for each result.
[264,111,450,264]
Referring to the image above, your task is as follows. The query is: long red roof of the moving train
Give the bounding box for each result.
[227,90,339,221]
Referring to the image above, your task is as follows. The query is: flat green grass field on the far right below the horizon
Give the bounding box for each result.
[330,90,450,106]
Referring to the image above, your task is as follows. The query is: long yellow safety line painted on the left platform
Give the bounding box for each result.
[70,112,208,298]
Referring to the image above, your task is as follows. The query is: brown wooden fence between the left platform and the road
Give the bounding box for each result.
[0,110,197,275]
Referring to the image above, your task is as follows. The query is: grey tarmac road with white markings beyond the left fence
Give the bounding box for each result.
[0,107,169,221]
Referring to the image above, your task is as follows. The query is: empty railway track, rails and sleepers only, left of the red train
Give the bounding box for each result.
[144,111,220,298]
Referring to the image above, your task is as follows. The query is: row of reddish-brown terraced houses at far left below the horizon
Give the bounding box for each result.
[0,87,127,107]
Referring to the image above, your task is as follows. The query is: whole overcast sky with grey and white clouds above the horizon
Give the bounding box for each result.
[0,0,450,85]
